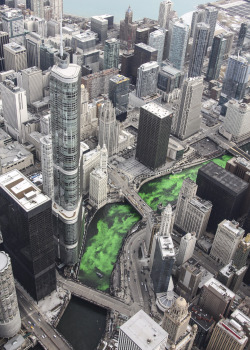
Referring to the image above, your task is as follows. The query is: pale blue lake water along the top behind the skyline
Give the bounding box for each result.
[63,0,208,23]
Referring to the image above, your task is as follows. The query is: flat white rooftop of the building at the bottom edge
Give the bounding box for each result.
[120,310,168,350]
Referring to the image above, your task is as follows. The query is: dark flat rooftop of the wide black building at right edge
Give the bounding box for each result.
[198,162,248,195]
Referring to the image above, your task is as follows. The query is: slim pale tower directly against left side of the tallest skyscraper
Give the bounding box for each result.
[40,135,54,198]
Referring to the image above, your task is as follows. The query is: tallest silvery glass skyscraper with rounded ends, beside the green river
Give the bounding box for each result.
[50,46,82,265]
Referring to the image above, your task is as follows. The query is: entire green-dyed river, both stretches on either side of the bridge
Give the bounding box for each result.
[78,155,231,291]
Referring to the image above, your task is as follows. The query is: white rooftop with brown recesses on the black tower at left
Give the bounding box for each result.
[0,169,50,212]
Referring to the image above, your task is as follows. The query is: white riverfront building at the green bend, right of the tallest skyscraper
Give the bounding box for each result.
[89,168,108,209]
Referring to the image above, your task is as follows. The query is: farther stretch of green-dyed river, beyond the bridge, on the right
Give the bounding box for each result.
[139,155,232,210]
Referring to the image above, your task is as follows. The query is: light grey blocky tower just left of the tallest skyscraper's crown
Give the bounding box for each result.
[22,67,43,105]
